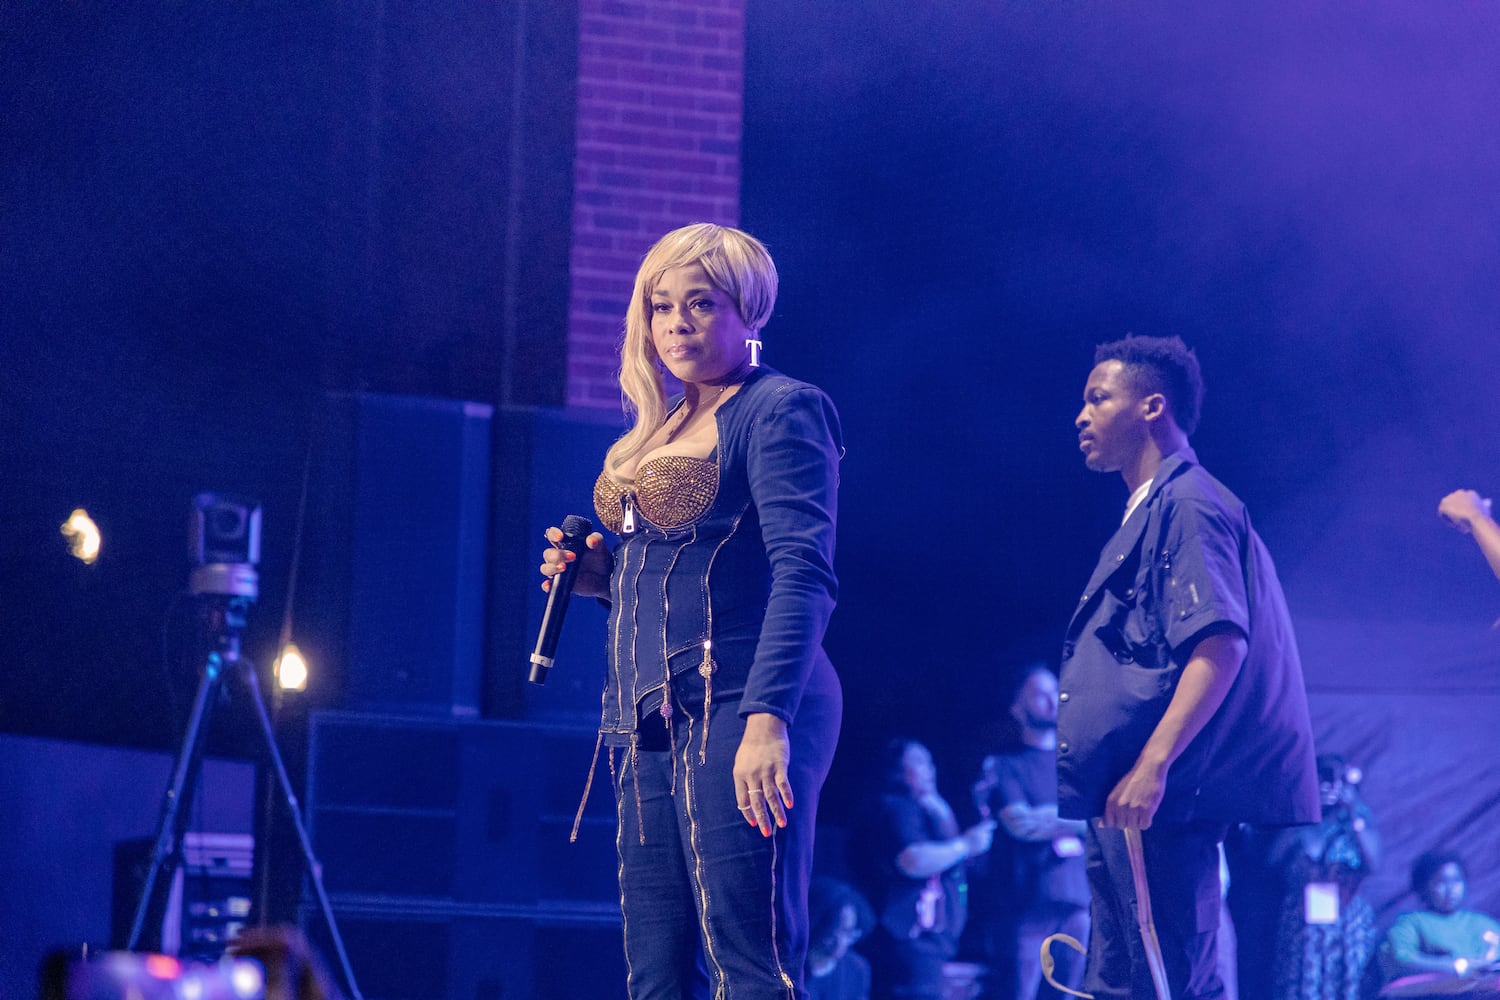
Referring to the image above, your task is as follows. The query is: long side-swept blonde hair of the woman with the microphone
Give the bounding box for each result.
[605,222,777,469]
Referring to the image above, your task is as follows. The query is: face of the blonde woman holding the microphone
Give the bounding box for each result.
[650,264,755,385]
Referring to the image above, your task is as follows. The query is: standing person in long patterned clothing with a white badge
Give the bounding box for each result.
[1272,754,1380,1000]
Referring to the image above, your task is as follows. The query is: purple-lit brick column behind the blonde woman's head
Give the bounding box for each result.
[567,0,746,409]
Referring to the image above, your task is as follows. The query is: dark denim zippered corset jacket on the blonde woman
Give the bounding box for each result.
[600,367,843,738]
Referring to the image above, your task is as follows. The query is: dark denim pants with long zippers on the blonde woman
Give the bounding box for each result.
[614,678,842,1000]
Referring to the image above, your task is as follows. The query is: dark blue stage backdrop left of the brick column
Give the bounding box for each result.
[0,1,578,745]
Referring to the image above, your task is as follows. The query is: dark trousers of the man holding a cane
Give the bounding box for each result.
[1083,820,1226,1000]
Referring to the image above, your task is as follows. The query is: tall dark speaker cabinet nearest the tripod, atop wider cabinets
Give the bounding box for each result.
[297,393,492,715]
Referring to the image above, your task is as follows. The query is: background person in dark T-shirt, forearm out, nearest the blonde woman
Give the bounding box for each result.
[858,739,995,1000]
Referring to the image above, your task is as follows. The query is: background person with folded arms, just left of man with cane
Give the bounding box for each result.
[974,663,1089,1000]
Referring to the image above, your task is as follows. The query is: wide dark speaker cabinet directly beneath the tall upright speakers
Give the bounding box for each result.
[306,712,618,906]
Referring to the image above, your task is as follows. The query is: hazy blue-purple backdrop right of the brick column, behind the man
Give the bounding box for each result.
[743,0,1500,909]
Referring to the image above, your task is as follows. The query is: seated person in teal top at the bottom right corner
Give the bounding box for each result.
[1380,850,1500,981]
